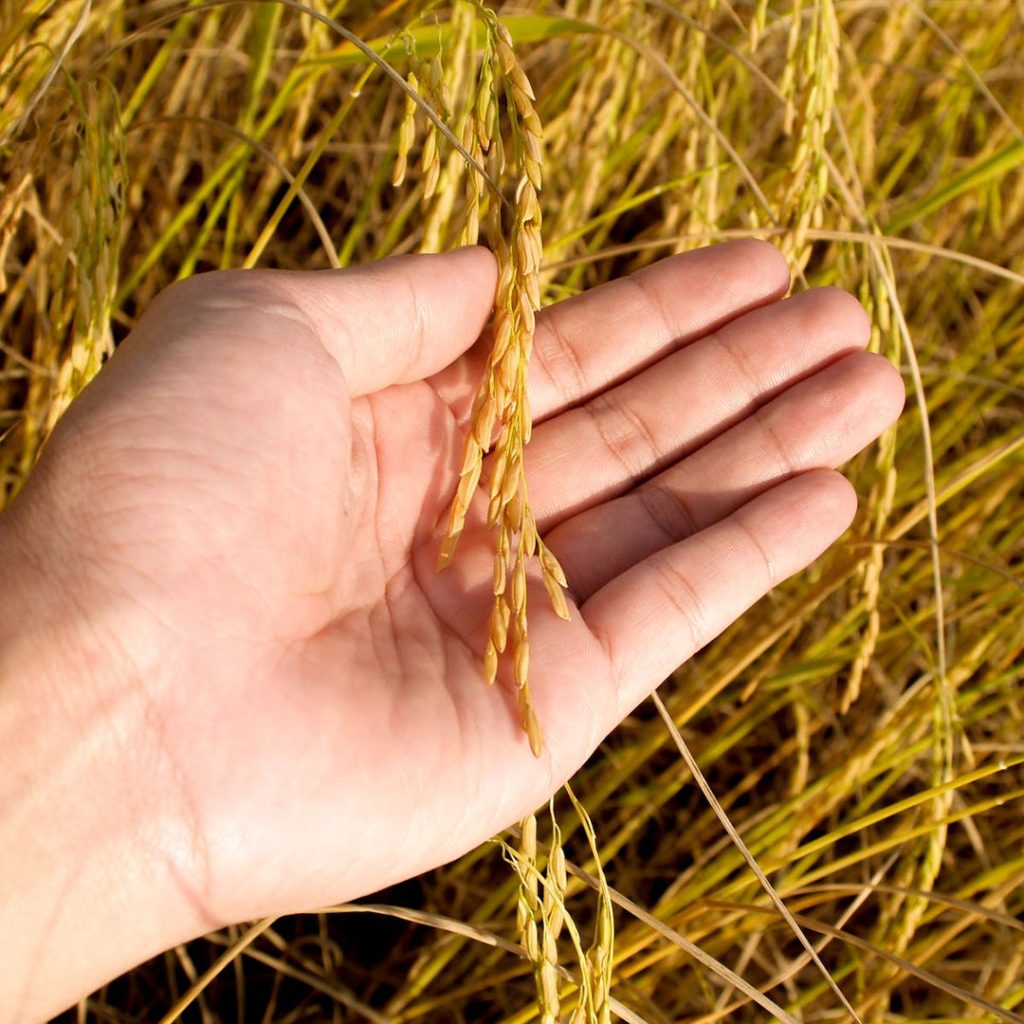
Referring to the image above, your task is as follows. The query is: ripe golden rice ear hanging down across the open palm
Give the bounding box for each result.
[428,4,568,753]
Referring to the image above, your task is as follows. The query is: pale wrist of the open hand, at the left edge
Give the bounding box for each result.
[0,501,213,1021]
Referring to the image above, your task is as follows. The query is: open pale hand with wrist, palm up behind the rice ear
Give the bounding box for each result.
[0,242,903,1020]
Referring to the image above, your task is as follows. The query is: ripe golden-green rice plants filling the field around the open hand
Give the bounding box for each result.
[0,0,1024,1024]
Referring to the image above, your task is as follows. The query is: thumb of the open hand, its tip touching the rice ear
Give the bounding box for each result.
[280,246,498,397]
